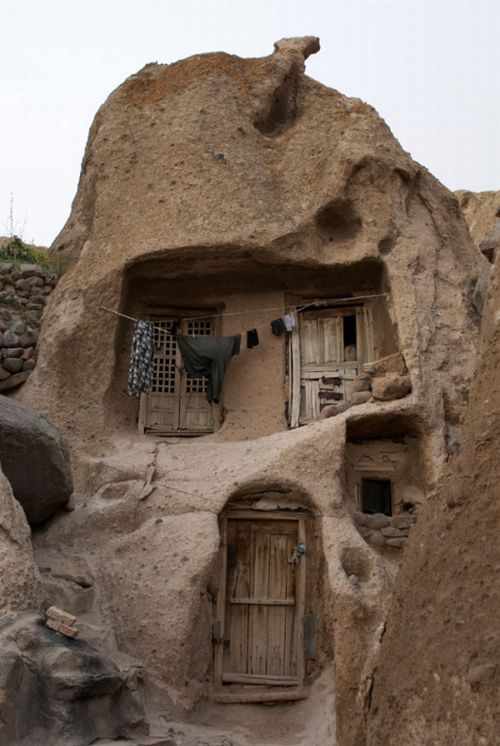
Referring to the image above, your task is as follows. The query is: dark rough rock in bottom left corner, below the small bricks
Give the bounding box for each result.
[0,614,144,746]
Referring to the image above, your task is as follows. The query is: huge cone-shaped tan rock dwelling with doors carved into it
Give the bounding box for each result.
[2,37,492,746]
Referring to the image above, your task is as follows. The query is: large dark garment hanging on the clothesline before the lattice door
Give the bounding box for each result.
[177,334,241,404]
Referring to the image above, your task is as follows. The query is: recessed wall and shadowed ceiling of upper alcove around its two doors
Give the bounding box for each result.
[107,253,397,440]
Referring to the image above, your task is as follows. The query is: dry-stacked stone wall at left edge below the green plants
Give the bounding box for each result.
[0,262,57,392]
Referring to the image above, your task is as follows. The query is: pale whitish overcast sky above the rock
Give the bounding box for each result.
[0,0,500,244]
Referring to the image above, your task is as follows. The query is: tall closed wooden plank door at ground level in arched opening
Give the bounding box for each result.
[219,514,305,686]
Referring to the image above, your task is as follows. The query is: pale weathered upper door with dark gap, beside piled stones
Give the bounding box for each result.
[290,306,373,427]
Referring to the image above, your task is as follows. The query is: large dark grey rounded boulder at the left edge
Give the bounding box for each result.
[0,396,73,523]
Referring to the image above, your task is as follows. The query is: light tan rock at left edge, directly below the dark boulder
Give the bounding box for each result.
[0,469,43,617]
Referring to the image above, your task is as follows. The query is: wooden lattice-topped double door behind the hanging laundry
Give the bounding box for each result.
[139,318,214,435]
